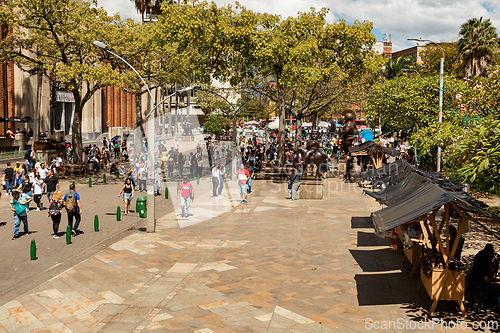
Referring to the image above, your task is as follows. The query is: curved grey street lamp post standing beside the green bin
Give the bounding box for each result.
[92,41,158,232]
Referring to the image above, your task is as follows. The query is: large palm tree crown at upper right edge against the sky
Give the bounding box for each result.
[458,17,498,79]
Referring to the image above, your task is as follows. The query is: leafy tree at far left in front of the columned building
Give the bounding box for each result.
[0,0,119,164]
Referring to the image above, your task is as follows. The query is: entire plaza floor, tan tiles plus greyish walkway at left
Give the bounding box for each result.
[0,141,496,333]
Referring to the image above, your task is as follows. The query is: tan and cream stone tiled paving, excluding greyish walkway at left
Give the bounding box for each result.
[0,175,482,333]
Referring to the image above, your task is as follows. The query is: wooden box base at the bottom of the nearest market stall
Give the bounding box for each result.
[420,268,465,302]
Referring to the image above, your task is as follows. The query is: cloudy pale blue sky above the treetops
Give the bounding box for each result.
[98,0,500,52]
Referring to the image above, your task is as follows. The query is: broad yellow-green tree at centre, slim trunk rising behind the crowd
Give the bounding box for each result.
[252,8,375,166]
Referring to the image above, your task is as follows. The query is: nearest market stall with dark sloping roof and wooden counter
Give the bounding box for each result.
[371,169,500,315]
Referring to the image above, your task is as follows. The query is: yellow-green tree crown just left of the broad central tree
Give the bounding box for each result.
[152,0,258,86]
